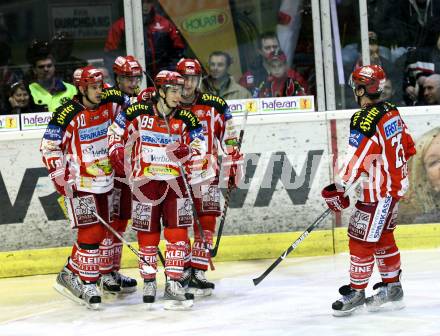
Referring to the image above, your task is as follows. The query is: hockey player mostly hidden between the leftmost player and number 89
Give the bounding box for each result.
[99,55,142,293]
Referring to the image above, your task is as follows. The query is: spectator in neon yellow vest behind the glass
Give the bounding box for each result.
[26,41,77,112]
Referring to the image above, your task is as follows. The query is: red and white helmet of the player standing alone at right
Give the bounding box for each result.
[350,65,386,96]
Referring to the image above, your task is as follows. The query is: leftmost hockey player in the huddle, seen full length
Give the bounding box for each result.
[40,66,119,309]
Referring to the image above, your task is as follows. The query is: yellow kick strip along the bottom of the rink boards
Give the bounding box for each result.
[0,224,440,278]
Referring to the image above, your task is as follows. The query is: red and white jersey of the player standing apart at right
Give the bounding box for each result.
[340,102,415,202]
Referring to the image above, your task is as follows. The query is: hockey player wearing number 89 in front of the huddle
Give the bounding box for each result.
[109,71,205,310]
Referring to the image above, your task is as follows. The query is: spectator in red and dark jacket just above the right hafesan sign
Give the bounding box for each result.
[259,49,305,97]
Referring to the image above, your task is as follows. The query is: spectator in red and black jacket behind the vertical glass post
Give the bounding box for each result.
[104,0,185,78]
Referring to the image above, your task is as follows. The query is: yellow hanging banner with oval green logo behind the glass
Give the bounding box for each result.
[160,0,241,79]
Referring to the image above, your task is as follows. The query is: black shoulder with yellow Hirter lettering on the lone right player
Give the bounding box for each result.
[350,104,389,138]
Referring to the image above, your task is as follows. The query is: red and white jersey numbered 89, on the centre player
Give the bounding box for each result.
[108,102,206,180]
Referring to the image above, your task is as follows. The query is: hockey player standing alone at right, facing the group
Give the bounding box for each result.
[322,65,415,316]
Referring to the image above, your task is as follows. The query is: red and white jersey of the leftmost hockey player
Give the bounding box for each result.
[40,99,120,194]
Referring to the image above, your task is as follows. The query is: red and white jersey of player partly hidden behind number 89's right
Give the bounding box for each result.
[182,92,238,183]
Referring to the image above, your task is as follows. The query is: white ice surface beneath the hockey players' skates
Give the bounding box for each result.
[0,249,440,336]
